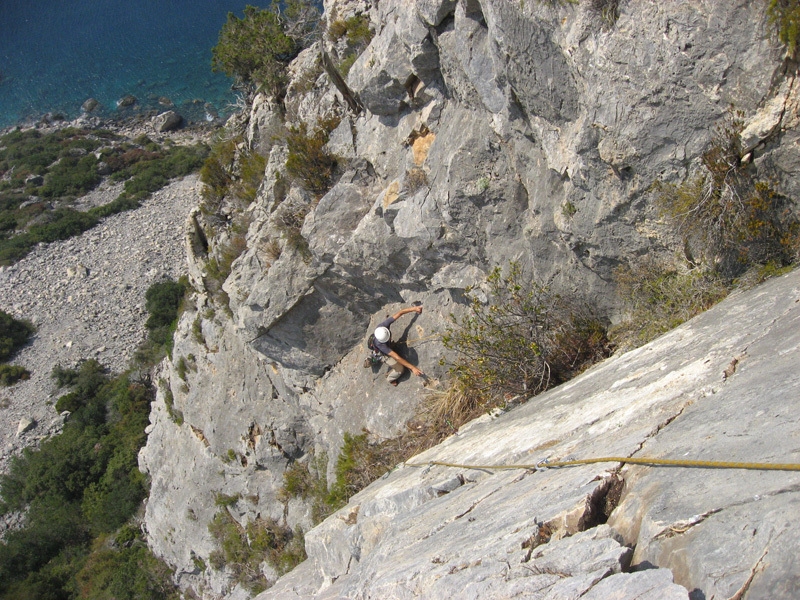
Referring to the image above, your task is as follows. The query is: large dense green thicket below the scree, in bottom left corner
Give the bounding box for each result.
[0,361,159,598]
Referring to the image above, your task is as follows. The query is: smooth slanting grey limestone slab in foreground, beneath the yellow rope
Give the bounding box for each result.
[258,271,800,600]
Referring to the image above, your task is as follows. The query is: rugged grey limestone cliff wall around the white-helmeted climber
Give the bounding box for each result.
[140,0,800,597]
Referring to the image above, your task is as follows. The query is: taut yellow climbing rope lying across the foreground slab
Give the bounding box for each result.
[405,456,800,471]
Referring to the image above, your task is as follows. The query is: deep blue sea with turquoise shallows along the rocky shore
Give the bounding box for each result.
[0,0,253,128]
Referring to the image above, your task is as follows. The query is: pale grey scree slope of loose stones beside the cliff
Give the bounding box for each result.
[0,175,200,472]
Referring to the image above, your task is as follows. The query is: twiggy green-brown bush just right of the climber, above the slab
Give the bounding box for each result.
[436,263,609,427]
